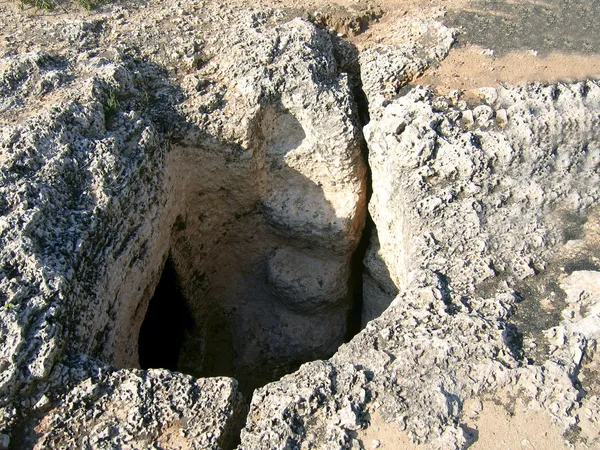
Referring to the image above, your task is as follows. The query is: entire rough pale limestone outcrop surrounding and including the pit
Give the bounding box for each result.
[0,2,600,449]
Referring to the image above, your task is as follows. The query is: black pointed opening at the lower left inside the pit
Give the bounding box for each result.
[138,257,194,371]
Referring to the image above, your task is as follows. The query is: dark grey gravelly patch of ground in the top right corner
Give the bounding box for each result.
[443,0,600,56]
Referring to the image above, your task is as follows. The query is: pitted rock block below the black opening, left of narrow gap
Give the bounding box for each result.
[20,361,245,449]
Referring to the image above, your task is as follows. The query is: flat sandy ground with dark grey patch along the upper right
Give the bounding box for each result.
[263,0,600,89]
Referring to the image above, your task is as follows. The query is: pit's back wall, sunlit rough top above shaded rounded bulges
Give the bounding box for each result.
[169,14,366,382]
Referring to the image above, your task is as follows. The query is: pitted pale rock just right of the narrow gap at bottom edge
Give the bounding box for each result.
[238,361,367,449]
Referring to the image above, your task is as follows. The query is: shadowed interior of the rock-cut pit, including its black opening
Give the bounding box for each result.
[138,101,368,400]
